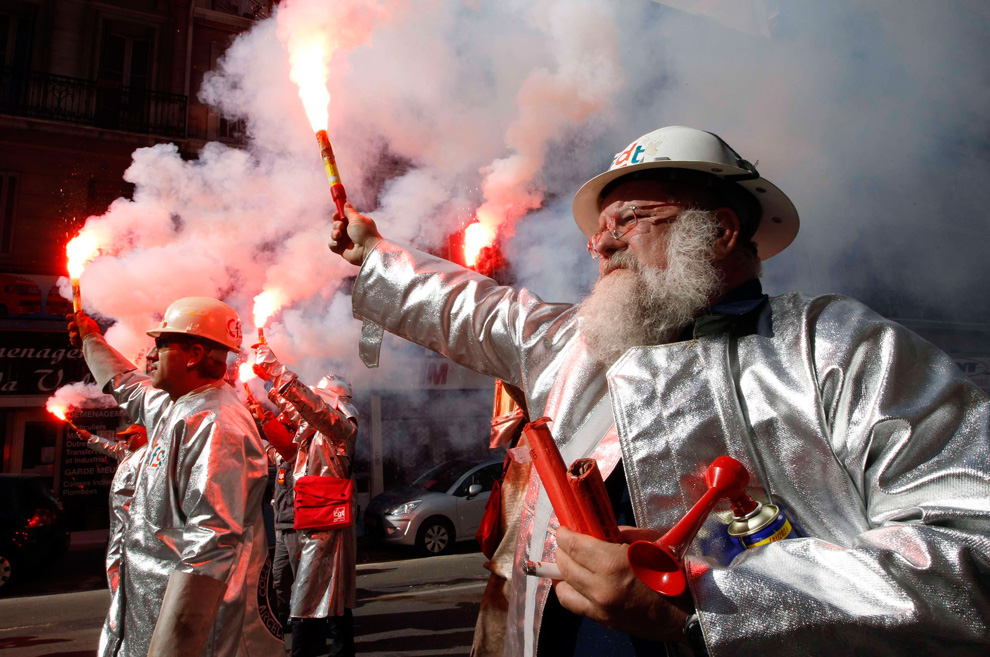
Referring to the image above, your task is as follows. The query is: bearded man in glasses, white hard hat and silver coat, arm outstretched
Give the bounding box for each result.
[330,127,990,657]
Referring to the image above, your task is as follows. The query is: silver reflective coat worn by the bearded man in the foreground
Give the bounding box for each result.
[353,242,990,656]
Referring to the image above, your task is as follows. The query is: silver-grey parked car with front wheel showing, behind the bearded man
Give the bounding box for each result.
[364,459,502,555]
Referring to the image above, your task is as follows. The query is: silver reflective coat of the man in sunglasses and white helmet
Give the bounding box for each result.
[83,336,282,656]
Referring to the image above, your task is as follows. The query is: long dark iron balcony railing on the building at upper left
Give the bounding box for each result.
[0,68,186,137]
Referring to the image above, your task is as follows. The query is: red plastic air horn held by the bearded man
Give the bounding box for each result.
[629,456,749,597]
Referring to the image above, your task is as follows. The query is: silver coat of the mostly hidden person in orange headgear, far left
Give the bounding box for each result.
[98,436,148,655]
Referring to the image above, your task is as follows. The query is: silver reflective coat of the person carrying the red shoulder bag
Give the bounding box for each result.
[269,371,357,618]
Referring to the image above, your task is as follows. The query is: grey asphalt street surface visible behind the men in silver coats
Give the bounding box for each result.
[0,541,488,657]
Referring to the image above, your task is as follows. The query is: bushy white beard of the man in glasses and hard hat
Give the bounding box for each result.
[578,210,722,367]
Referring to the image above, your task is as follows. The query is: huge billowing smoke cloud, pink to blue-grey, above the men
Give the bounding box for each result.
[66,0,990,394]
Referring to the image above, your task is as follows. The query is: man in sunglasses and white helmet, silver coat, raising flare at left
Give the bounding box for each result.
[69,297,281,657]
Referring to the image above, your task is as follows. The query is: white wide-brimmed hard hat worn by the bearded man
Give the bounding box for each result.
[573,126,799,260]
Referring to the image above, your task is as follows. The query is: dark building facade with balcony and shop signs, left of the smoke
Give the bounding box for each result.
[0,0,274,530]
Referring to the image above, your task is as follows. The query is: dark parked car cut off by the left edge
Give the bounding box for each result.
[0,474,69,595]
